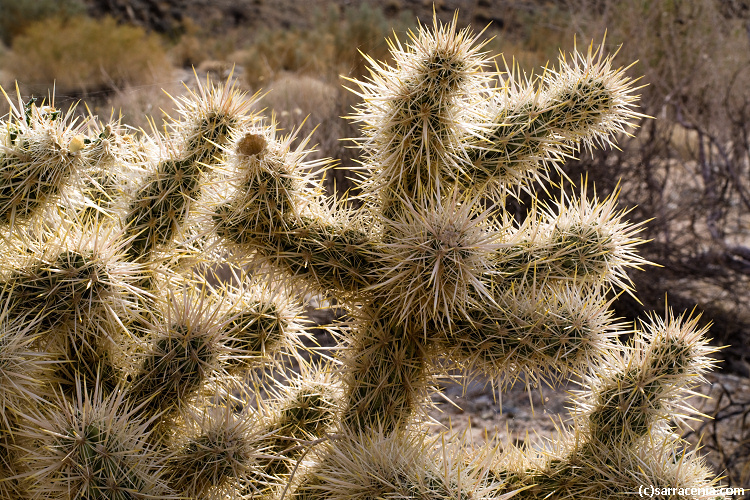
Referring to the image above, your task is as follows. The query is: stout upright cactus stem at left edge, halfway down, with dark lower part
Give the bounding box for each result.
[0,226,142,402]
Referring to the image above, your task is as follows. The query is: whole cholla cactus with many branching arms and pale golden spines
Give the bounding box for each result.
[0,13,728,500]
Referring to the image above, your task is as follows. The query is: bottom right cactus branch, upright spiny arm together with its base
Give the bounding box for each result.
[498,311,723,500]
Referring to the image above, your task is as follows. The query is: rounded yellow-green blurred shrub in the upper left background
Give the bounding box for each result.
[7,17,168,94]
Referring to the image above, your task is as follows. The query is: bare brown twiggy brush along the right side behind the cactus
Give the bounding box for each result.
[568,0,750,376]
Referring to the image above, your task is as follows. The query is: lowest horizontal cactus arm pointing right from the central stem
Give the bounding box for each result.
[444,284,623,387]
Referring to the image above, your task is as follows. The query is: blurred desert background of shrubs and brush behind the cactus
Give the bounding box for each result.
[0,0,750,377]
